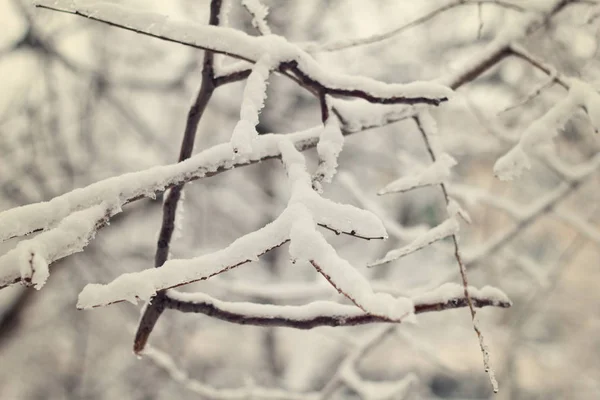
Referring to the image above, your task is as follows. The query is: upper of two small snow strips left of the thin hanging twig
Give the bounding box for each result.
[377,153,456,195]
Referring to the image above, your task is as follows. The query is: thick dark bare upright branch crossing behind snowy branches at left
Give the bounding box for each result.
[133,0,222,353]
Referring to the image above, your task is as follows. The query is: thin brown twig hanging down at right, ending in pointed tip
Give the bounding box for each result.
[413,116,498,393]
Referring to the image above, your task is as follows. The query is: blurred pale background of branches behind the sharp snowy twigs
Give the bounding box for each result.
[0,0,600,399]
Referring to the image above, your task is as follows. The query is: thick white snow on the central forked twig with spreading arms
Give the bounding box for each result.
[77,136,394,310]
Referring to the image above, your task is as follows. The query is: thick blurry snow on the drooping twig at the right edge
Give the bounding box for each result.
[494,78,600,180]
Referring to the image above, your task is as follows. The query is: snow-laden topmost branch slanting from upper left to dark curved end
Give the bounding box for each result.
[36,0,453,105]
